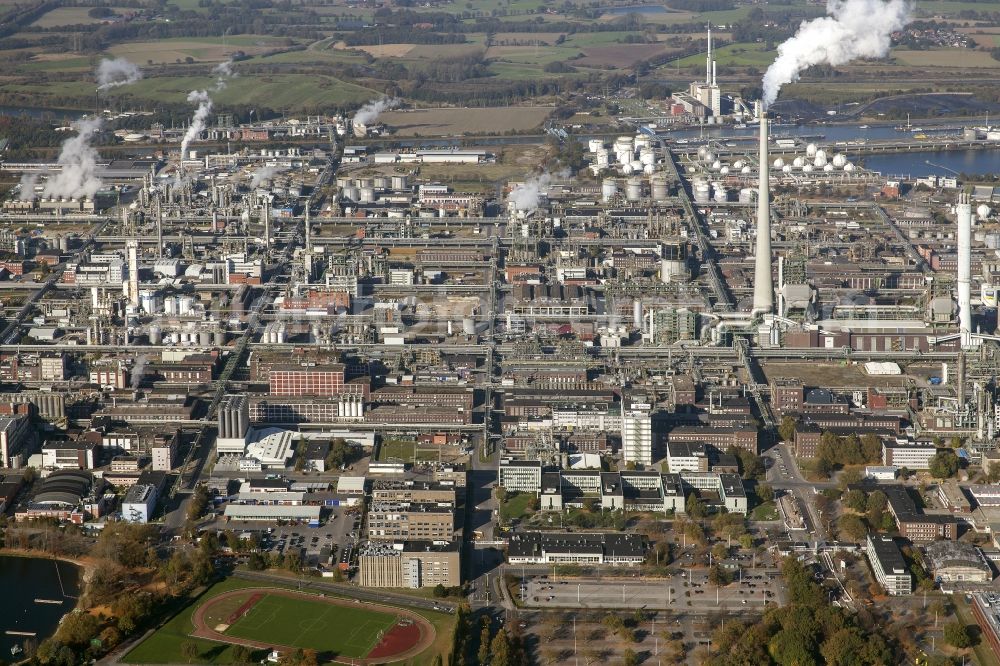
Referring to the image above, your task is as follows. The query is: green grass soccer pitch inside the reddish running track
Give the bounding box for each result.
[226,594,396,657]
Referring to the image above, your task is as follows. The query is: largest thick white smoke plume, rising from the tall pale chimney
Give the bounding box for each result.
[763,0,912,108]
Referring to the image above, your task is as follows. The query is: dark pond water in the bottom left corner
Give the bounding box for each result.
[0,557,81,661]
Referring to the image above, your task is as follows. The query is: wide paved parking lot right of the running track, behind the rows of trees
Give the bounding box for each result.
[524,569,781,611]
